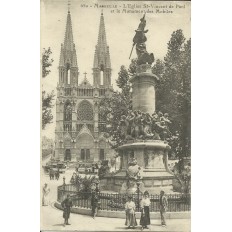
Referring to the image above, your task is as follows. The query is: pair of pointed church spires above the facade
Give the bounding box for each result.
[59,10,111,87]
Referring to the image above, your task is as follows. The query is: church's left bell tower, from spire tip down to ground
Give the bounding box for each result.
[55,10,79,160]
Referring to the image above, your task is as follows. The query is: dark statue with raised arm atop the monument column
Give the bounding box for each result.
[129,14,155,65]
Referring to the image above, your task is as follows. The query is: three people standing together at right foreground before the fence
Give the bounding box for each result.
[125,191,168,230]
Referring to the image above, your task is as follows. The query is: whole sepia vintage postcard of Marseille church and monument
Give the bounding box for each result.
[40,0,191,232]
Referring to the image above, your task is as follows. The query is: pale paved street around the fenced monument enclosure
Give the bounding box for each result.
[41,161,190,232]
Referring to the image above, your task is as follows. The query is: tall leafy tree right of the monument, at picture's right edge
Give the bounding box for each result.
[153,30,191,160]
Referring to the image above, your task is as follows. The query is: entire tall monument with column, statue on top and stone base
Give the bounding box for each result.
[100,15,174,194]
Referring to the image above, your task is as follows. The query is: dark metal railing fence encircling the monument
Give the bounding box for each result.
[57,185,191,212]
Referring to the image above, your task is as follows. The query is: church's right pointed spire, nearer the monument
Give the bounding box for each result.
[93,13,111,87]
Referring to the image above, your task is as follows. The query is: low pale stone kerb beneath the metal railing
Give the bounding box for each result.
[54,202,191,219]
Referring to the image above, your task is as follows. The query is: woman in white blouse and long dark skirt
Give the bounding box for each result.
[140,191,151,230]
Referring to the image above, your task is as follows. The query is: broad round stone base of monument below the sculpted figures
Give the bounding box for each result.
[102,140,174,194]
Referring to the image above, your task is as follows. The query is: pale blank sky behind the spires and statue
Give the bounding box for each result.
[41,0,191,138]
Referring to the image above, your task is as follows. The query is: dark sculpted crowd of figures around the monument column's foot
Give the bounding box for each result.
[117,110,171,140]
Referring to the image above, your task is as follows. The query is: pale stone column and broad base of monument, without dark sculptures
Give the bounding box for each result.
[101,64,174,194]
